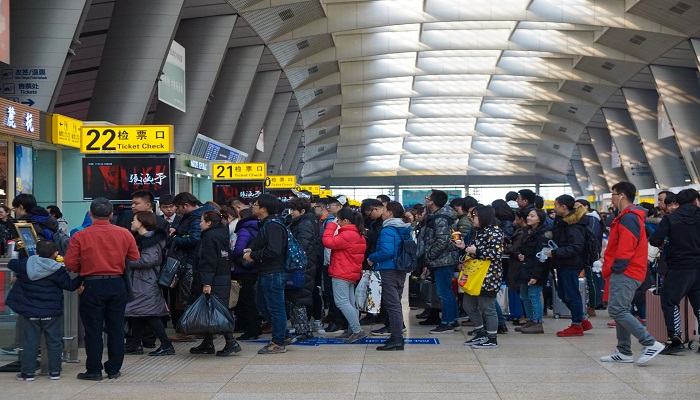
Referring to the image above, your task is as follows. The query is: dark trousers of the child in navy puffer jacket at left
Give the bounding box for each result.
[22,317,63,376]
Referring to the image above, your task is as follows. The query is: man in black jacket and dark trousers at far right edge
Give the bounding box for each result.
[649,189,700,354]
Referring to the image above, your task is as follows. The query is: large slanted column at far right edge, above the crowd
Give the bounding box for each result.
[650,65,700,183]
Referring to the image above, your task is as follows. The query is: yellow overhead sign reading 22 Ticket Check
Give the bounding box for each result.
[80,125,175,153]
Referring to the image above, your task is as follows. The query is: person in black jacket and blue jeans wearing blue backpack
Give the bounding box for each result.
[243,194,292,354]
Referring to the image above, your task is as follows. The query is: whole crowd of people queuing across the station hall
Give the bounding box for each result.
[0,182,700,381]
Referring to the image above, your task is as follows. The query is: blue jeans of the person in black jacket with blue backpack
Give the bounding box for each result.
[257,272,288,346]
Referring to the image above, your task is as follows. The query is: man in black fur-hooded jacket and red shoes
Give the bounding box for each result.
[547,194,593,337]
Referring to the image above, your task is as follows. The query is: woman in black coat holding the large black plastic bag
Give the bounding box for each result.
[190,210,241,357]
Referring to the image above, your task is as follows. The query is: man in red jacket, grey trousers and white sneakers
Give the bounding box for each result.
[600,182,665,364]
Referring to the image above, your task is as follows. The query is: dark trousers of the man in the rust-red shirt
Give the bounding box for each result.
[79,277,126,375]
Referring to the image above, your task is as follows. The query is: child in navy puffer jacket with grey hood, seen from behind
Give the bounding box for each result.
[7,240,83,381]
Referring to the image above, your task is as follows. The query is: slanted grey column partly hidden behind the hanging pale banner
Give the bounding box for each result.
[153,15,236,153]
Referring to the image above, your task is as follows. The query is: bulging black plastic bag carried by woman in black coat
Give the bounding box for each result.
[175,294,236,335]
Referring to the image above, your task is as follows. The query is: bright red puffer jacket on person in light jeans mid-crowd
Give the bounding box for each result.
[323,222,367,282]
